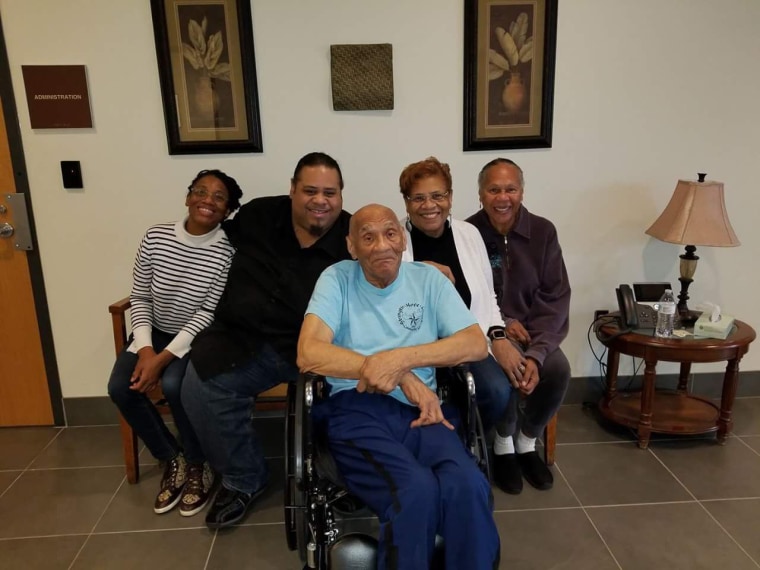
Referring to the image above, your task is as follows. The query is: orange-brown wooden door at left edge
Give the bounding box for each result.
[0,93,57,426]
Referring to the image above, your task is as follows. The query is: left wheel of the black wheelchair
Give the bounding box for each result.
[285,380,308,561]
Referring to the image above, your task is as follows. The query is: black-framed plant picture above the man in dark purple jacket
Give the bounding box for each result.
[464,0,558,151]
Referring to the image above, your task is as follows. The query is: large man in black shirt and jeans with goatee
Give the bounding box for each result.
[182,152,350,528]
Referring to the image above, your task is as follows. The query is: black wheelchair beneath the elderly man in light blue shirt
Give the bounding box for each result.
[285,365,491,570]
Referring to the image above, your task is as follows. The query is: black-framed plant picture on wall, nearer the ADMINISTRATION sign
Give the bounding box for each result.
[150,0,263,155]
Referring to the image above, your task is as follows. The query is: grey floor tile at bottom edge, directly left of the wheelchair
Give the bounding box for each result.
[207,524,303,570]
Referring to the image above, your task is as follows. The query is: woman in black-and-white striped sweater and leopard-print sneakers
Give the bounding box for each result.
[108,170,243,516]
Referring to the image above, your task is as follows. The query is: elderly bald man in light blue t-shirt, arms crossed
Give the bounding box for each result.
[296,205,499,570]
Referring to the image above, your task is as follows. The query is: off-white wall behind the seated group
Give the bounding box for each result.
[0,0,760,397]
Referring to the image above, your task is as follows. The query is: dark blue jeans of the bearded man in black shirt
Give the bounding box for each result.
[182,344,298,493]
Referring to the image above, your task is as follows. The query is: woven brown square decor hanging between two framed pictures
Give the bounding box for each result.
[330,44,393,111]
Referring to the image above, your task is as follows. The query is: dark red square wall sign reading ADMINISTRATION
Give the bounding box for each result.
[21,65,92,129]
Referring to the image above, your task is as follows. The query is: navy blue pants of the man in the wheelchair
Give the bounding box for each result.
[314,390,499,570]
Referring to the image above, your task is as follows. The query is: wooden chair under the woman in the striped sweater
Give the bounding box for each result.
[108,297,288,483]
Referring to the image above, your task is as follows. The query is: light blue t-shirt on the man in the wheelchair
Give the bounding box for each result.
[306,261,477,405]
